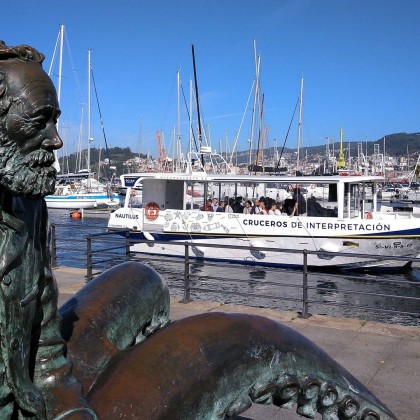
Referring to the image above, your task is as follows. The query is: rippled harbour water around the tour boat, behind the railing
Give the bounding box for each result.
[49,210,420,326]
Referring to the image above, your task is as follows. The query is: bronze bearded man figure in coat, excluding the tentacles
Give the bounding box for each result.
[0,42,95,419]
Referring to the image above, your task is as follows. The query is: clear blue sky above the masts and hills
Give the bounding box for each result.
[0,0,420,158]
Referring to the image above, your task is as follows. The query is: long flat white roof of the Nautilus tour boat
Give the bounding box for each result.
[121,172,385,187]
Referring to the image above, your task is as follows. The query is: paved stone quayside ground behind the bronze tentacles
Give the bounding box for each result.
[53,267,420,420]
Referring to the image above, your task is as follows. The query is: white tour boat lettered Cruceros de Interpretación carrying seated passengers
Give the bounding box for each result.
[108,172,420,270]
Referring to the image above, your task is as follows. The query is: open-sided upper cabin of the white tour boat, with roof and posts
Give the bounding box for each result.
[121,173,384,218]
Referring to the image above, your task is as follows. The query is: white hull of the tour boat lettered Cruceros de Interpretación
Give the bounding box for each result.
[108,208,420,271]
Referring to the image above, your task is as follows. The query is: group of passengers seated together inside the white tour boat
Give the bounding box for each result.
[201,189,307,216]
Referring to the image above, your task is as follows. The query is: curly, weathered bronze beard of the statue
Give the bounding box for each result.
[0,143,57,198]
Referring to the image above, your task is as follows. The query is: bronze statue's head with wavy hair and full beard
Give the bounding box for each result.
[0,41,63,198]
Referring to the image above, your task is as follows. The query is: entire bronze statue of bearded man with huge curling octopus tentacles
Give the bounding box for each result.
[0,42,395,419]
